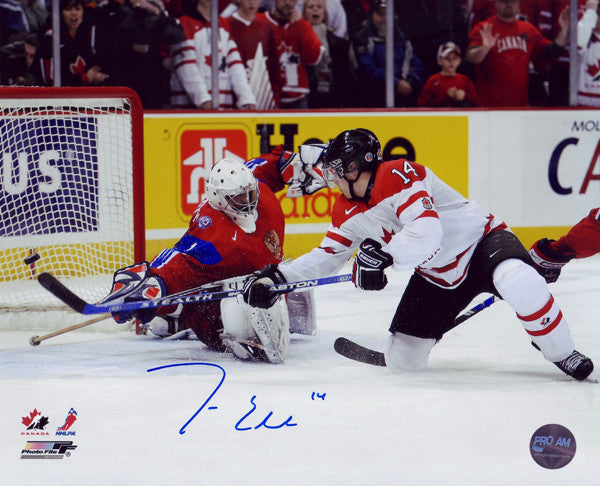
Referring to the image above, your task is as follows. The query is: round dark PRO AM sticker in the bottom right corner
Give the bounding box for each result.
[529,424,577,469]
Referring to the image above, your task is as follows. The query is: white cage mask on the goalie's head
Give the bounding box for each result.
[205,159,259,233]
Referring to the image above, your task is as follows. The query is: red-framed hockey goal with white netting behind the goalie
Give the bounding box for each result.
[0,87,145,312]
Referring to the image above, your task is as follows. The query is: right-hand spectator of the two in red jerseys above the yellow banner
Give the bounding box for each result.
[266,0,325,109]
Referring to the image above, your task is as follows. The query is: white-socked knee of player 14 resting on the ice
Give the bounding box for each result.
[385,332,436,372]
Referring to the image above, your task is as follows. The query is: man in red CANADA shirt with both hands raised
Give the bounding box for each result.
[465,0,569,107]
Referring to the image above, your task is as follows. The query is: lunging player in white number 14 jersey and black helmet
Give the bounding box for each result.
[244,129,594,380]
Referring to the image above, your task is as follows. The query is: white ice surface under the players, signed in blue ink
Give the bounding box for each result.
[0,257,600,486]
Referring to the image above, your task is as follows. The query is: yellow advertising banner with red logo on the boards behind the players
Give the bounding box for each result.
[144,111,468,257]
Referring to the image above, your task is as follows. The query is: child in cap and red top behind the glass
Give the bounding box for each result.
[417,42,479,107]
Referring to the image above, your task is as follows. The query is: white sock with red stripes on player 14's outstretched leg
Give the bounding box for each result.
[493,259,575,362]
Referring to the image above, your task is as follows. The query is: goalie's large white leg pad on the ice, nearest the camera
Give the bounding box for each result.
[221,297,290,364]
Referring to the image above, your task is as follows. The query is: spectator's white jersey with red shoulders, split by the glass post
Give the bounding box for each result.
[170,15,256,108]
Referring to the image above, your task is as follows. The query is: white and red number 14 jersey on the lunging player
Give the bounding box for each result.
[279,159,507,288]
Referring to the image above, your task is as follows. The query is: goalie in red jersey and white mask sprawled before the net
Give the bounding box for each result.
[97,145,326,363]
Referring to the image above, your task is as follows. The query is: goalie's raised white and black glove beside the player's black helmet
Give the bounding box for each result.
[280,144,327,198]
